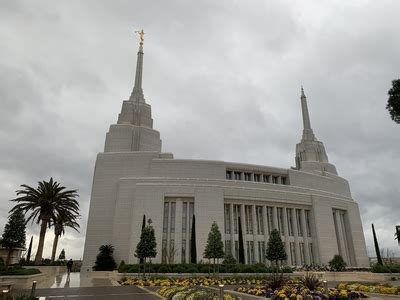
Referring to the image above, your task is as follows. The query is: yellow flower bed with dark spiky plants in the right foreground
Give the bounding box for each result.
[235,285,367,300]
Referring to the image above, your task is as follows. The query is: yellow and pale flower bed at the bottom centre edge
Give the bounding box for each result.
[157,286,237,300]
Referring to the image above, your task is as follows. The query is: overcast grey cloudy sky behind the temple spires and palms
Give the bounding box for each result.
[0,0,400,259]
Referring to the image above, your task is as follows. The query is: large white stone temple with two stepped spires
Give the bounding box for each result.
[82,38,369,271]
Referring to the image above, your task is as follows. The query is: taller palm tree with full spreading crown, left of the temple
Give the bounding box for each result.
[10,178,79,265]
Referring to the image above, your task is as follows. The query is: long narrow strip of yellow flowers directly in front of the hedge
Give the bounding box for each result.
[120,277,266,286]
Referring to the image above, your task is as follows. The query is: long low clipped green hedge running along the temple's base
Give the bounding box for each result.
[118,262,292,273]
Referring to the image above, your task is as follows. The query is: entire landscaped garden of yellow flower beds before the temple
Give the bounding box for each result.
[120,273,400,300]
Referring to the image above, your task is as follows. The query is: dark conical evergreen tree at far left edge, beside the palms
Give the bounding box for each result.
[2,209,26,268]
